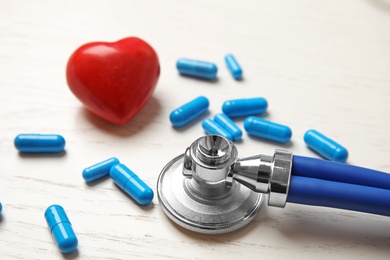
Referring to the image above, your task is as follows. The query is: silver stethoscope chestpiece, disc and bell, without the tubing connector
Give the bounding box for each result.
[157,135,264,234]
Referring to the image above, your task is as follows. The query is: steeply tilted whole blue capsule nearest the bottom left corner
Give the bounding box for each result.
[45,205,78,254]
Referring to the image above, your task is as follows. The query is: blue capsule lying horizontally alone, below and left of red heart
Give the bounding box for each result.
[14,134,65,153]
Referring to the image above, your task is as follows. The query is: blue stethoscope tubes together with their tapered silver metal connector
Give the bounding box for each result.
[227,150,390,216]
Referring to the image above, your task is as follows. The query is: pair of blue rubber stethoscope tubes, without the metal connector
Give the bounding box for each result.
[287,156,390,216]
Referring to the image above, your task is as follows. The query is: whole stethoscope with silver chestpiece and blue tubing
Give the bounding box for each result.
[157,135,390,234]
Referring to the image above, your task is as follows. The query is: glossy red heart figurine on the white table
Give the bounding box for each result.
[66,37,160,124]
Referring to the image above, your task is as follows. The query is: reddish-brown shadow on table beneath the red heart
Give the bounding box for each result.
[77,96,162,137]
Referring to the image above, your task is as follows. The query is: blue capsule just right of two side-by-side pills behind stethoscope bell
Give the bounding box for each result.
[244,116,292,143]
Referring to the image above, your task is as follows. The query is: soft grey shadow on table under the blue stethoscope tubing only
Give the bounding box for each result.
[279,205,390,245]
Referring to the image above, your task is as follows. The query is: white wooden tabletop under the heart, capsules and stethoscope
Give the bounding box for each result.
[0,0,390,259]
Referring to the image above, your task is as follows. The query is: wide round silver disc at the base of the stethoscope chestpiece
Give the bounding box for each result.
[157,155,264,234]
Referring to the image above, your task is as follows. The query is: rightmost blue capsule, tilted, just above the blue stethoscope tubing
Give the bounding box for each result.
[304,130,348,162]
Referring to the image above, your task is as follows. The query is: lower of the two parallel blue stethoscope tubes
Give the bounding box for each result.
[287,176,390,216]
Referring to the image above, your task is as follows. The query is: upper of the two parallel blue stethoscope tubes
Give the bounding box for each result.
[291,155,390,190]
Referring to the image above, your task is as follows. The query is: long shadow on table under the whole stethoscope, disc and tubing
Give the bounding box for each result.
[167,205,390,252]
